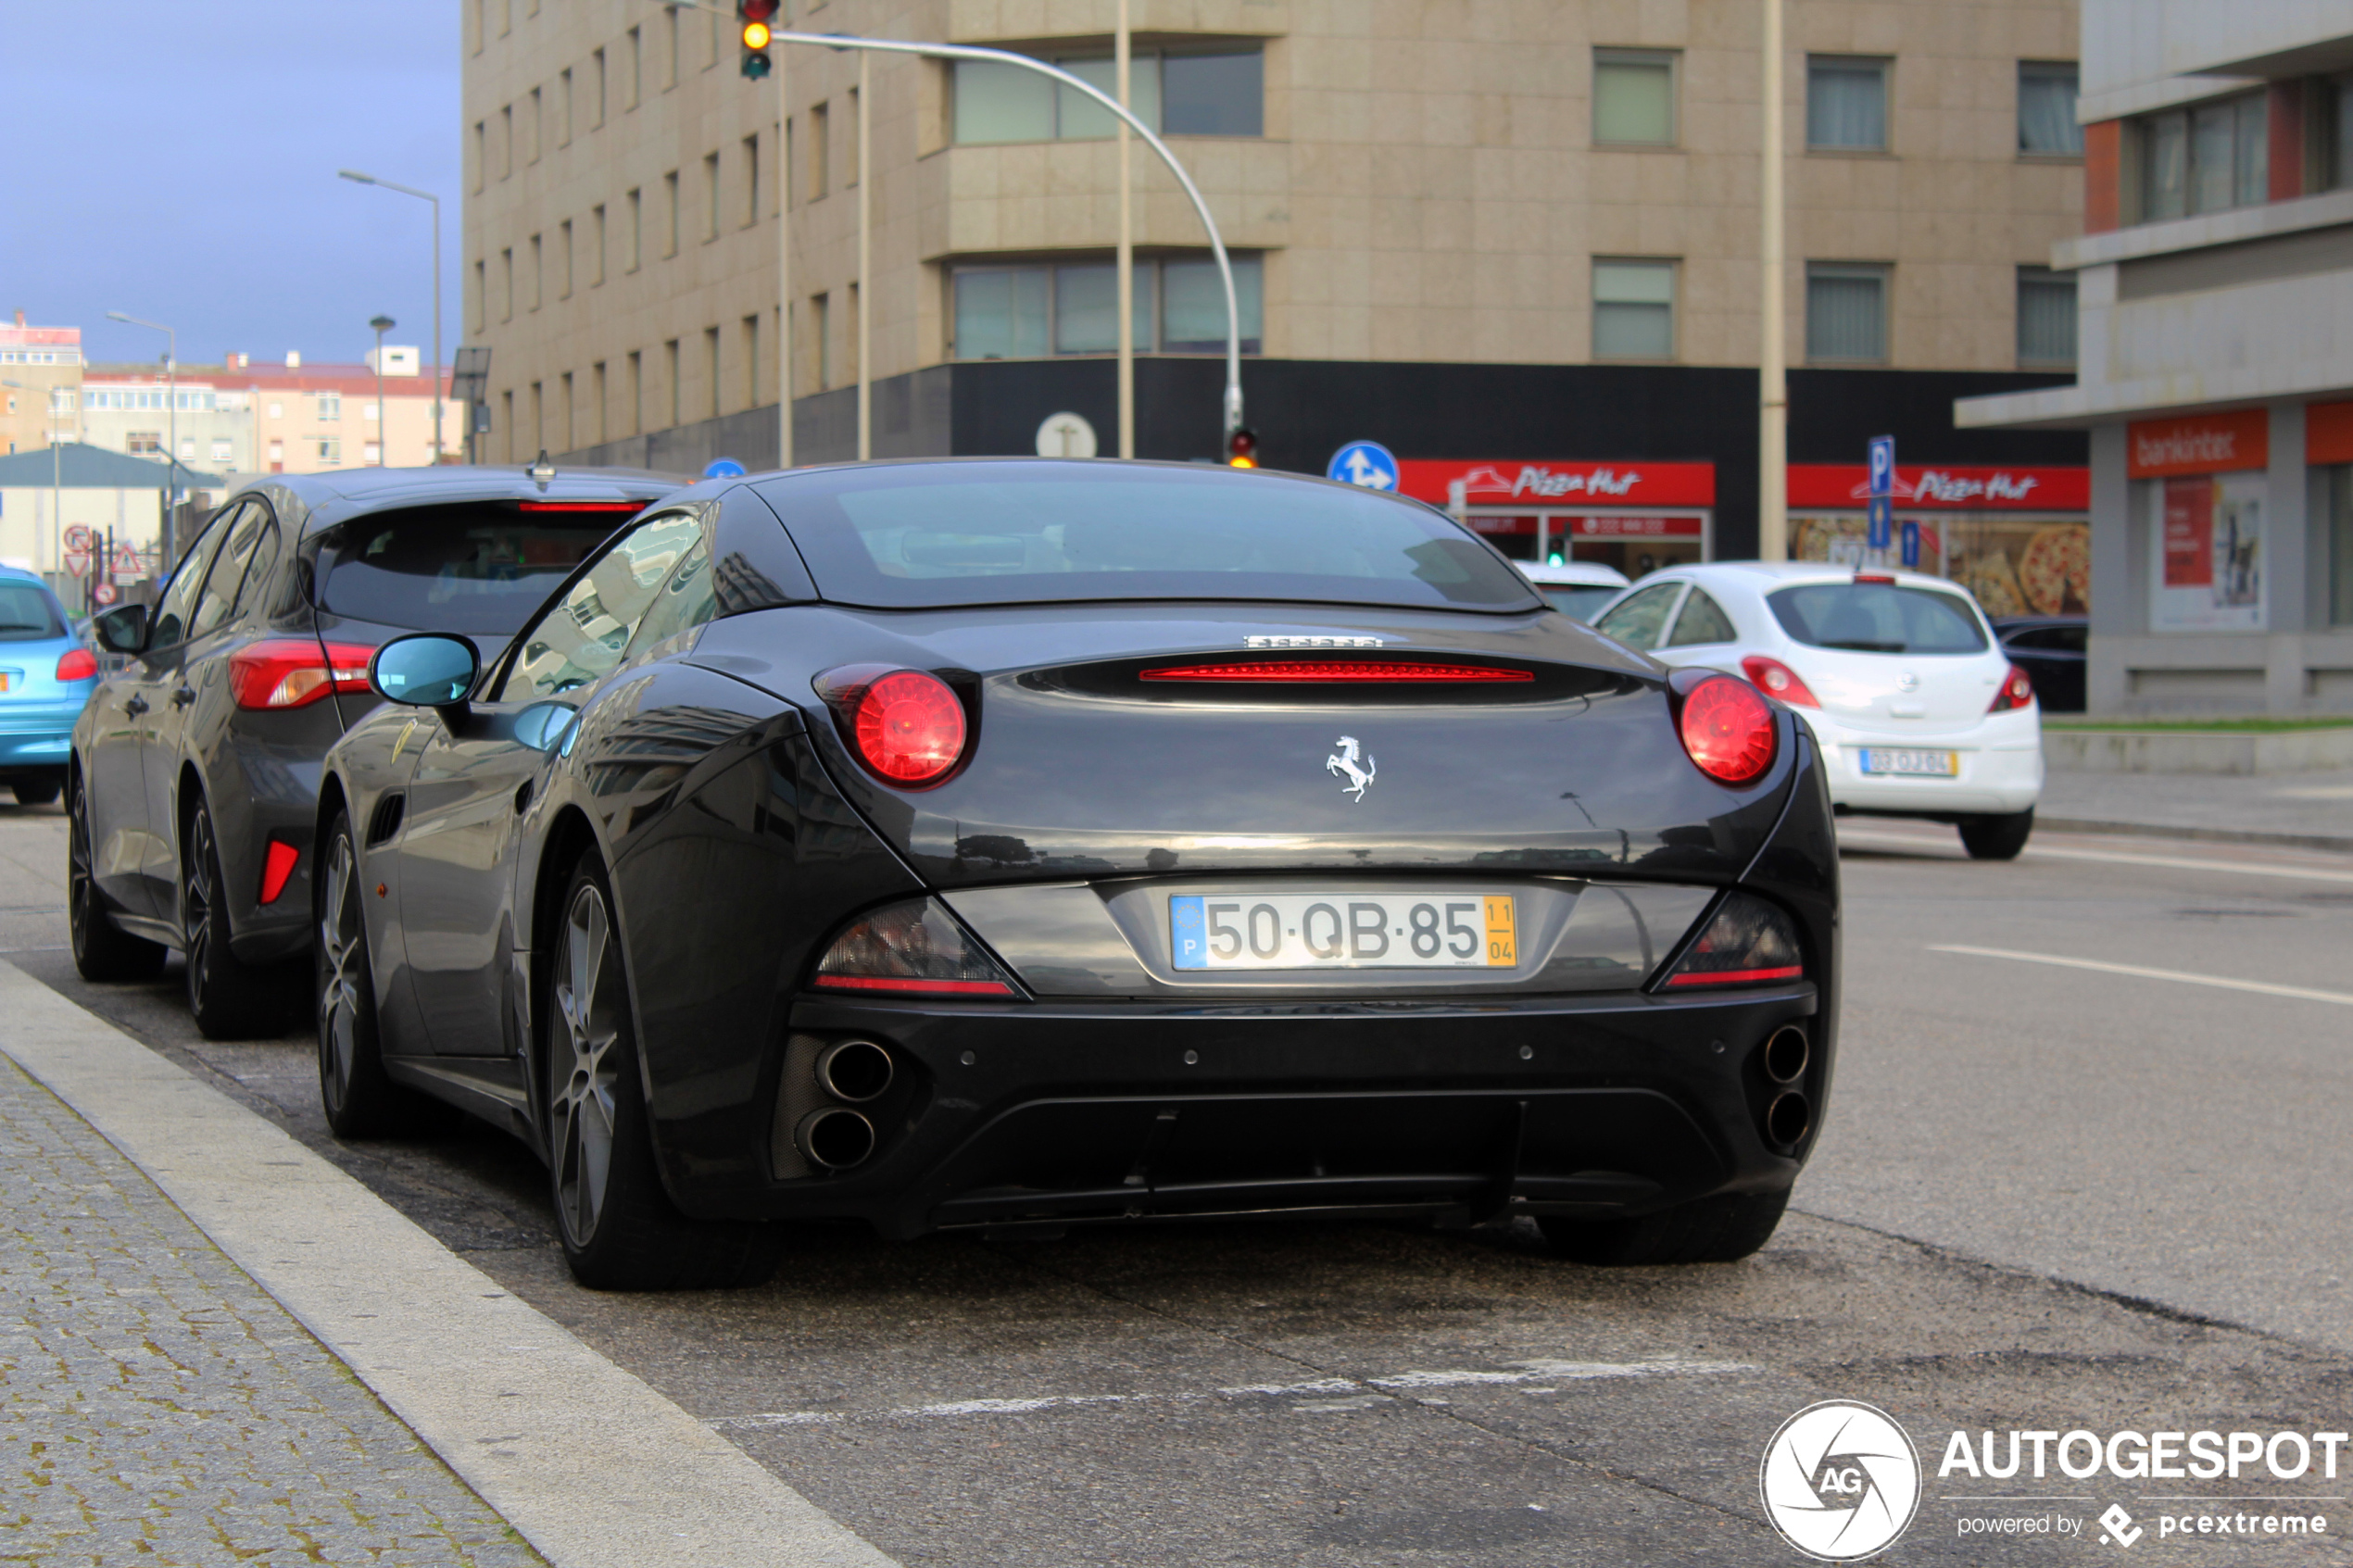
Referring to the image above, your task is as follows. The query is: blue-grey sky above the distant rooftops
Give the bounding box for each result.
[0,0,461,364]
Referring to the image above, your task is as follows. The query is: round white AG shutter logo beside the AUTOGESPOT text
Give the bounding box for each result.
[1757,1399,1920,1563]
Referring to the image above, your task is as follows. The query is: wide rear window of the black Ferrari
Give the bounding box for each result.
[760,460,1537,611]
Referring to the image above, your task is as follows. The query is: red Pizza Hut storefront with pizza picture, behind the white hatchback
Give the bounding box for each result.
[1788,463,2092,616]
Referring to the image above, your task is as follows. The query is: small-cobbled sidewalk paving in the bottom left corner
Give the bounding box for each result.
[0,1056,541,1568]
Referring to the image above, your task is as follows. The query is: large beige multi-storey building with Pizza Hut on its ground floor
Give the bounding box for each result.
[461,0,2087,571]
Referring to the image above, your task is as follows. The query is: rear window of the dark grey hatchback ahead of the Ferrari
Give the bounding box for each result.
[318,501,628,637]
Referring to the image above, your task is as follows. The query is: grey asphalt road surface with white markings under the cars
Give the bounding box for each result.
[0,809,2353,1568]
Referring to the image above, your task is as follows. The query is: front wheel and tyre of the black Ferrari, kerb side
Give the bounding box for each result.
[315,811,452,1138]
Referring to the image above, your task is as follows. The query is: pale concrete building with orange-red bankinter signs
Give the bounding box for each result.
[1957,0,2353,715]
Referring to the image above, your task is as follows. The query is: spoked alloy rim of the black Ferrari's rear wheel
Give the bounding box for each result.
[548,884,626,1246]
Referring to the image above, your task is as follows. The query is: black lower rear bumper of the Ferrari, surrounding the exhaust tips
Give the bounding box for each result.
[673,985,1831,1236]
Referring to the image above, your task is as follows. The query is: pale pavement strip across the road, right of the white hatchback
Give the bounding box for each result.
[2035,769,2353,851]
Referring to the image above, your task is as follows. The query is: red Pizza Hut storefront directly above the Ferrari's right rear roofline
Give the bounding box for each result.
[1398,458,1716,578]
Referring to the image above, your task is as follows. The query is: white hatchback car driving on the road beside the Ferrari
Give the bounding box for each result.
[1593,562,2043,860]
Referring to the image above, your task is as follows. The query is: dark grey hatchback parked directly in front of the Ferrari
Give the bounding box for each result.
[66,468,678,1039]
